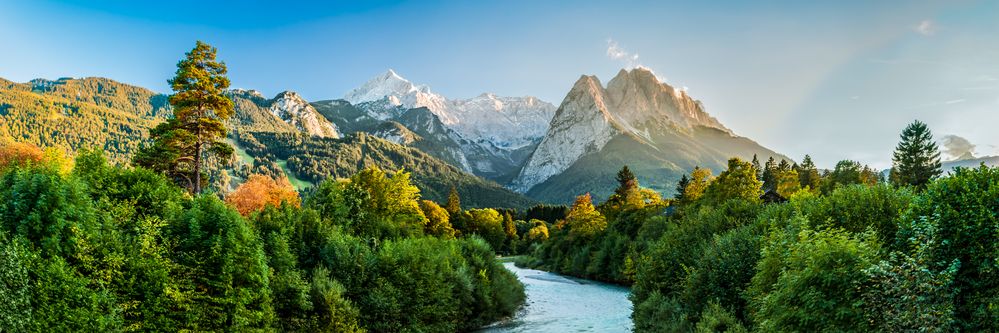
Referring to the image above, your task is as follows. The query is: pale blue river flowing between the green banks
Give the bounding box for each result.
[479,263,631,333]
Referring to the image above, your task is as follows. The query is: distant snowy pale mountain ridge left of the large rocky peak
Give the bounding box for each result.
[344,69,555,180]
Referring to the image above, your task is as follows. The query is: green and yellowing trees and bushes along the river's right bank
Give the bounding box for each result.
[518,121,999,332]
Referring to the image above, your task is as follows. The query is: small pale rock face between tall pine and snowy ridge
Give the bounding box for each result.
[269,91,340,138]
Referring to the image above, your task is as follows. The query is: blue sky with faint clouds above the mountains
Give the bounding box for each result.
[0,0,999,168]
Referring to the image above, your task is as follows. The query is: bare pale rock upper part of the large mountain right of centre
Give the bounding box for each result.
[510,67,734,192]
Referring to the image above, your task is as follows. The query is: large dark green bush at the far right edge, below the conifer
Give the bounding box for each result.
[898,166,999,331]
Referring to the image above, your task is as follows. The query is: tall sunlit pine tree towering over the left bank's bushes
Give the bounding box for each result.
[135,41,235,193]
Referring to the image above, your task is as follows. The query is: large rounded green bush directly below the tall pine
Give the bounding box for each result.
[167,195,274,330]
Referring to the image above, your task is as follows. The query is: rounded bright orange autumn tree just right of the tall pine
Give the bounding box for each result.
[225,174,301,216]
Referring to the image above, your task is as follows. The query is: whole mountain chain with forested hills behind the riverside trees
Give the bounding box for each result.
[0,67,790,204]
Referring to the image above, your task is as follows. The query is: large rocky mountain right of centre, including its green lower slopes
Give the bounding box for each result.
[509,68,787,202]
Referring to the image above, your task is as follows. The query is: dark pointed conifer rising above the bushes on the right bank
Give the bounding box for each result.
[891,120,942,188]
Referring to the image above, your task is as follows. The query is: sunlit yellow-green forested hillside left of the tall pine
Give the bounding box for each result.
[0,78,169,162]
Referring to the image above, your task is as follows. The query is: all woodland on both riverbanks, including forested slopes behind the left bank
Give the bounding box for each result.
[0,31,999,332]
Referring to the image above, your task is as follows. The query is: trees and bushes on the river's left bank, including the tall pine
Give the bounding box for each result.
[0,42,525,332]
